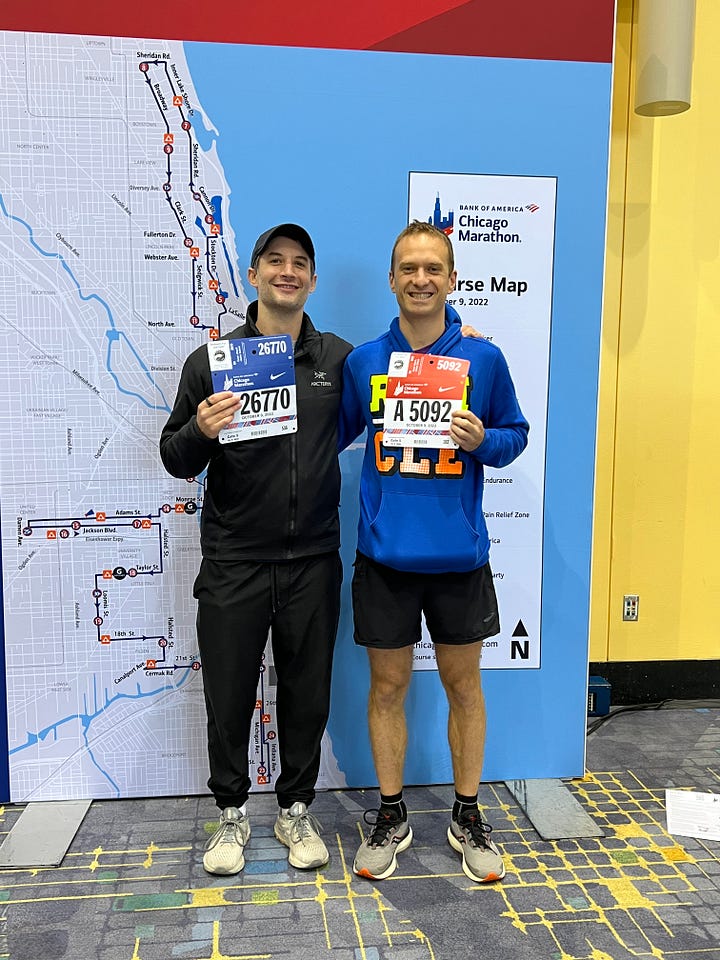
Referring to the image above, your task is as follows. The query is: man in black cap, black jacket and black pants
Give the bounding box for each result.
[160,223,351,875]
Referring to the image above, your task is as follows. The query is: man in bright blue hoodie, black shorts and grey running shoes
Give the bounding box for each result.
[340,221,528,882]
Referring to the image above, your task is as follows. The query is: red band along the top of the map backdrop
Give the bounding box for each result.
[0,0,615,63]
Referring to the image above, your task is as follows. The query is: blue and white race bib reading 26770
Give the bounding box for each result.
[208,334,297,443]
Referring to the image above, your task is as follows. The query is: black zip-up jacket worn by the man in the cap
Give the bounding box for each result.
[160,301,352,562]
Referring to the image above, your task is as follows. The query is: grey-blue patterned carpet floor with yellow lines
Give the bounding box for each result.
[0,709,720,960]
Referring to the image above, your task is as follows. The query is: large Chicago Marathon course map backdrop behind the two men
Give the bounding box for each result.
[0,3,612,801]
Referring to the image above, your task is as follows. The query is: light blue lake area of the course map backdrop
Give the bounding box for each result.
[185,43,611,785]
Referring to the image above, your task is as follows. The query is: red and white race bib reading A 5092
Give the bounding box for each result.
[383,353,470,448]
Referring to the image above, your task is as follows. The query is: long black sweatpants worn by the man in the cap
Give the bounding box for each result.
[193,553,342,809]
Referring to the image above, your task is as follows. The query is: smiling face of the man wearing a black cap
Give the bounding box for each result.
[248,237,317,311]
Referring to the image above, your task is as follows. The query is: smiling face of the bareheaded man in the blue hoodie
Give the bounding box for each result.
[390,233,457,323]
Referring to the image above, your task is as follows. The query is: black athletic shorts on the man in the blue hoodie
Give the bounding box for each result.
[352,553,500,650]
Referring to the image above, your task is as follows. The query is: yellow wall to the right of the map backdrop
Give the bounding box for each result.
[590,0,720,661]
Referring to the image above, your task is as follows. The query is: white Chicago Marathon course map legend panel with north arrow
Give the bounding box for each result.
[408,172,556,670]
